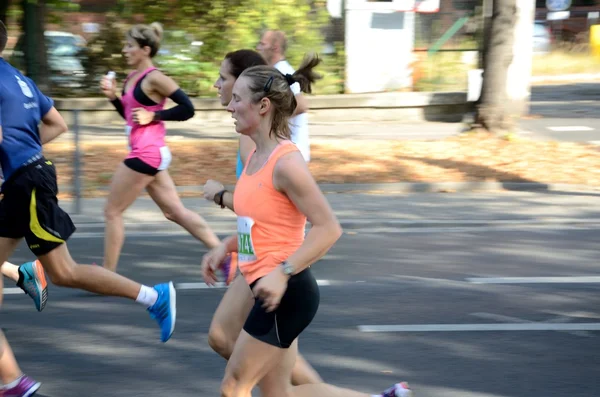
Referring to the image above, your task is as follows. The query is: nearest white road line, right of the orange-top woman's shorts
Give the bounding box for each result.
[358,323,600,332]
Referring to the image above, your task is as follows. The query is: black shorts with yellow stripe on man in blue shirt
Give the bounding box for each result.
[0,155,75,256]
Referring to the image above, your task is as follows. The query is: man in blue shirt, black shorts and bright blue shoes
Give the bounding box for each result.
[0,22,176,397]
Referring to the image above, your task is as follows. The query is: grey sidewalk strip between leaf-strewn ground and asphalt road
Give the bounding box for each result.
[61,192,600,233]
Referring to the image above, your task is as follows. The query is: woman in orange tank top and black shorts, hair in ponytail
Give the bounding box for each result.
[202,56,410,397]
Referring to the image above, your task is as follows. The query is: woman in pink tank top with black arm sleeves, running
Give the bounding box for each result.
[101,23,219,271]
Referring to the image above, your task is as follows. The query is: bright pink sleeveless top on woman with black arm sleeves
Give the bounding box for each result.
[121,67,171,169]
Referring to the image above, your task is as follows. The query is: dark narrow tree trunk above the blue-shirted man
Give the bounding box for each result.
[22,0,50,92]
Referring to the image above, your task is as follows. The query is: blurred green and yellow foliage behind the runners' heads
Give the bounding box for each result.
[65,0,343,96]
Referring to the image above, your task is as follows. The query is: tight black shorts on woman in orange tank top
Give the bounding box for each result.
[244,268,321,349]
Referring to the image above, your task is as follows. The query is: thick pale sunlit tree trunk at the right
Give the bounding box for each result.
[475,0,517,134]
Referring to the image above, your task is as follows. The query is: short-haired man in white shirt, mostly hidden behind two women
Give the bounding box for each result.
[256,30,310,163]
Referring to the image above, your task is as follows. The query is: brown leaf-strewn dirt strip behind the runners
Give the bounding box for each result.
[39,134,600,197]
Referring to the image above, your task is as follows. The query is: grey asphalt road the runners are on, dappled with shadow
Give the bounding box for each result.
[1,225,600,397]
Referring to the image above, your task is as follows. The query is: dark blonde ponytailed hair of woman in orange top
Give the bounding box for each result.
[240,54,322,139]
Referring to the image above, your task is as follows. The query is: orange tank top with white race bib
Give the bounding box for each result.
[233,141,306,284]
